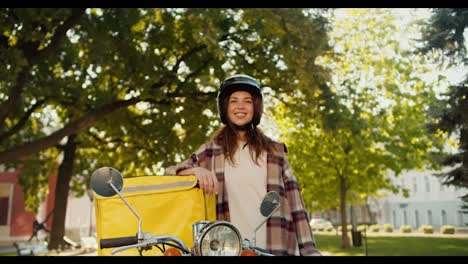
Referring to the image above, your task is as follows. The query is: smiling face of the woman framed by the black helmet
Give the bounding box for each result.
[227,91,254,126]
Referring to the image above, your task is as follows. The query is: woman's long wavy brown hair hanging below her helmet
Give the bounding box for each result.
[213,96,274,165]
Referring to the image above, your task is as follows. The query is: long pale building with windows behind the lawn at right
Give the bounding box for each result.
[311,170,468,229]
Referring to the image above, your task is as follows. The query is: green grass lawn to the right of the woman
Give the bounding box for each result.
[314,234,468,256]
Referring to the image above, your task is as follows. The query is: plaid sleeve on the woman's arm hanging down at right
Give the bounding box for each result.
[283,154,321,256]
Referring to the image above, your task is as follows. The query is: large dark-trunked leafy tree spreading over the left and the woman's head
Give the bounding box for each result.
[0,8,328,249]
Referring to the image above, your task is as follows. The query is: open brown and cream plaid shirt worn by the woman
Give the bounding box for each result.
[164,141,321,256]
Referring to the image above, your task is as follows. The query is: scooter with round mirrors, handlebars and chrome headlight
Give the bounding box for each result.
[91,167,280,256]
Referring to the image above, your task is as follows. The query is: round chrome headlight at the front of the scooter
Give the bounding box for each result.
[194,221,242,256]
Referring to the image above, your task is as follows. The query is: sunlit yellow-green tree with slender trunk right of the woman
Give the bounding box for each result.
[278,9,443,248]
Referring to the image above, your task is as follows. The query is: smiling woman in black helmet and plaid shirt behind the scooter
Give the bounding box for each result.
[165,75,321,255]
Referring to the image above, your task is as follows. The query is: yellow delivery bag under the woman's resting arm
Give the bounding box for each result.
[94,175,216,256]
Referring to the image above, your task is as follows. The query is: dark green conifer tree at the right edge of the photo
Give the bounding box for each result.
[420,8,468,213]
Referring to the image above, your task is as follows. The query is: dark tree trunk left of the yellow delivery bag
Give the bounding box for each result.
[48,134,76,250]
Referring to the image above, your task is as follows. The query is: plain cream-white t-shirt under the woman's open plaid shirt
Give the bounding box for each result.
[224,141,267,248]
